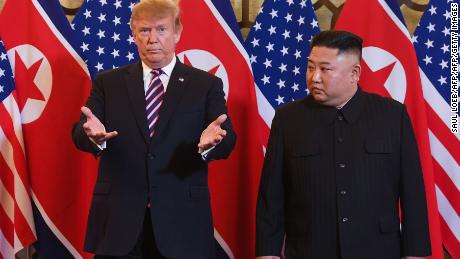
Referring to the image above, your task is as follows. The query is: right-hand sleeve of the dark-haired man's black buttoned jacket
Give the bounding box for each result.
[400,107,431,256]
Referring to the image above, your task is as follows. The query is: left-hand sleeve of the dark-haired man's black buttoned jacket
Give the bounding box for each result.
[256,112,285,256]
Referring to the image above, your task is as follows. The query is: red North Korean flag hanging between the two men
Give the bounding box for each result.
[177,0,263,258]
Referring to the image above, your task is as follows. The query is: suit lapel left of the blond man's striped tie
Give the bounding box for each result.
[125,62,150,143]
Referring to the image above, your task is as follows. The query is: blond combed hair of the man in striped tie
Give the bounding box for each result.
[129,0,182,31]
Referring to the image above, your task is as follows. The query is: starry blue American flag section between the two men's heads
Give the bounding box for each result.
[245,0,319,132]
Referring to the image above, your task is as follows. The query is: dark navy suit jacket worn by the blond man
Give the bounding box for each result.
[73,60,236,258]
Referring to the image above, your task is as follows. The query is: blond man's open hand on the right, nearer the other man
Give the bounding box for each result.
[198,114,227,154]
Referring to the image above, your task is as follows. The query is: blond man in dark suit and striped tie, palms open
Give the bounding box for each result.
[73,0,236,259]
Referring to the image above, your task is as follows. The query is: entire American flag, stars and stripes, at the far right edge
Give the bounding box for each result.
[412,0,460,258]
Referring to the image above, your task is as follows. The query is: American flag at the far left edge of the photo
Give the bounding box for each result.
[0,39,36,259]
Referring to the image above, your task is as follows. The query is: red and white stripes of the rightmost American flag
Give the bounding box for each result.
[421,71,460,259]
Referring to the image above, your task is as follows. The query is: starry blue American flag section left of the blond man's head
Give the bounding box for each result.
[72,0,139,78]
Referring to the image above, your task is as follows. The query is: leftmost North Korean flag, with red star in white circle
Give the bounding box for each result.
[0,0,96,258]
